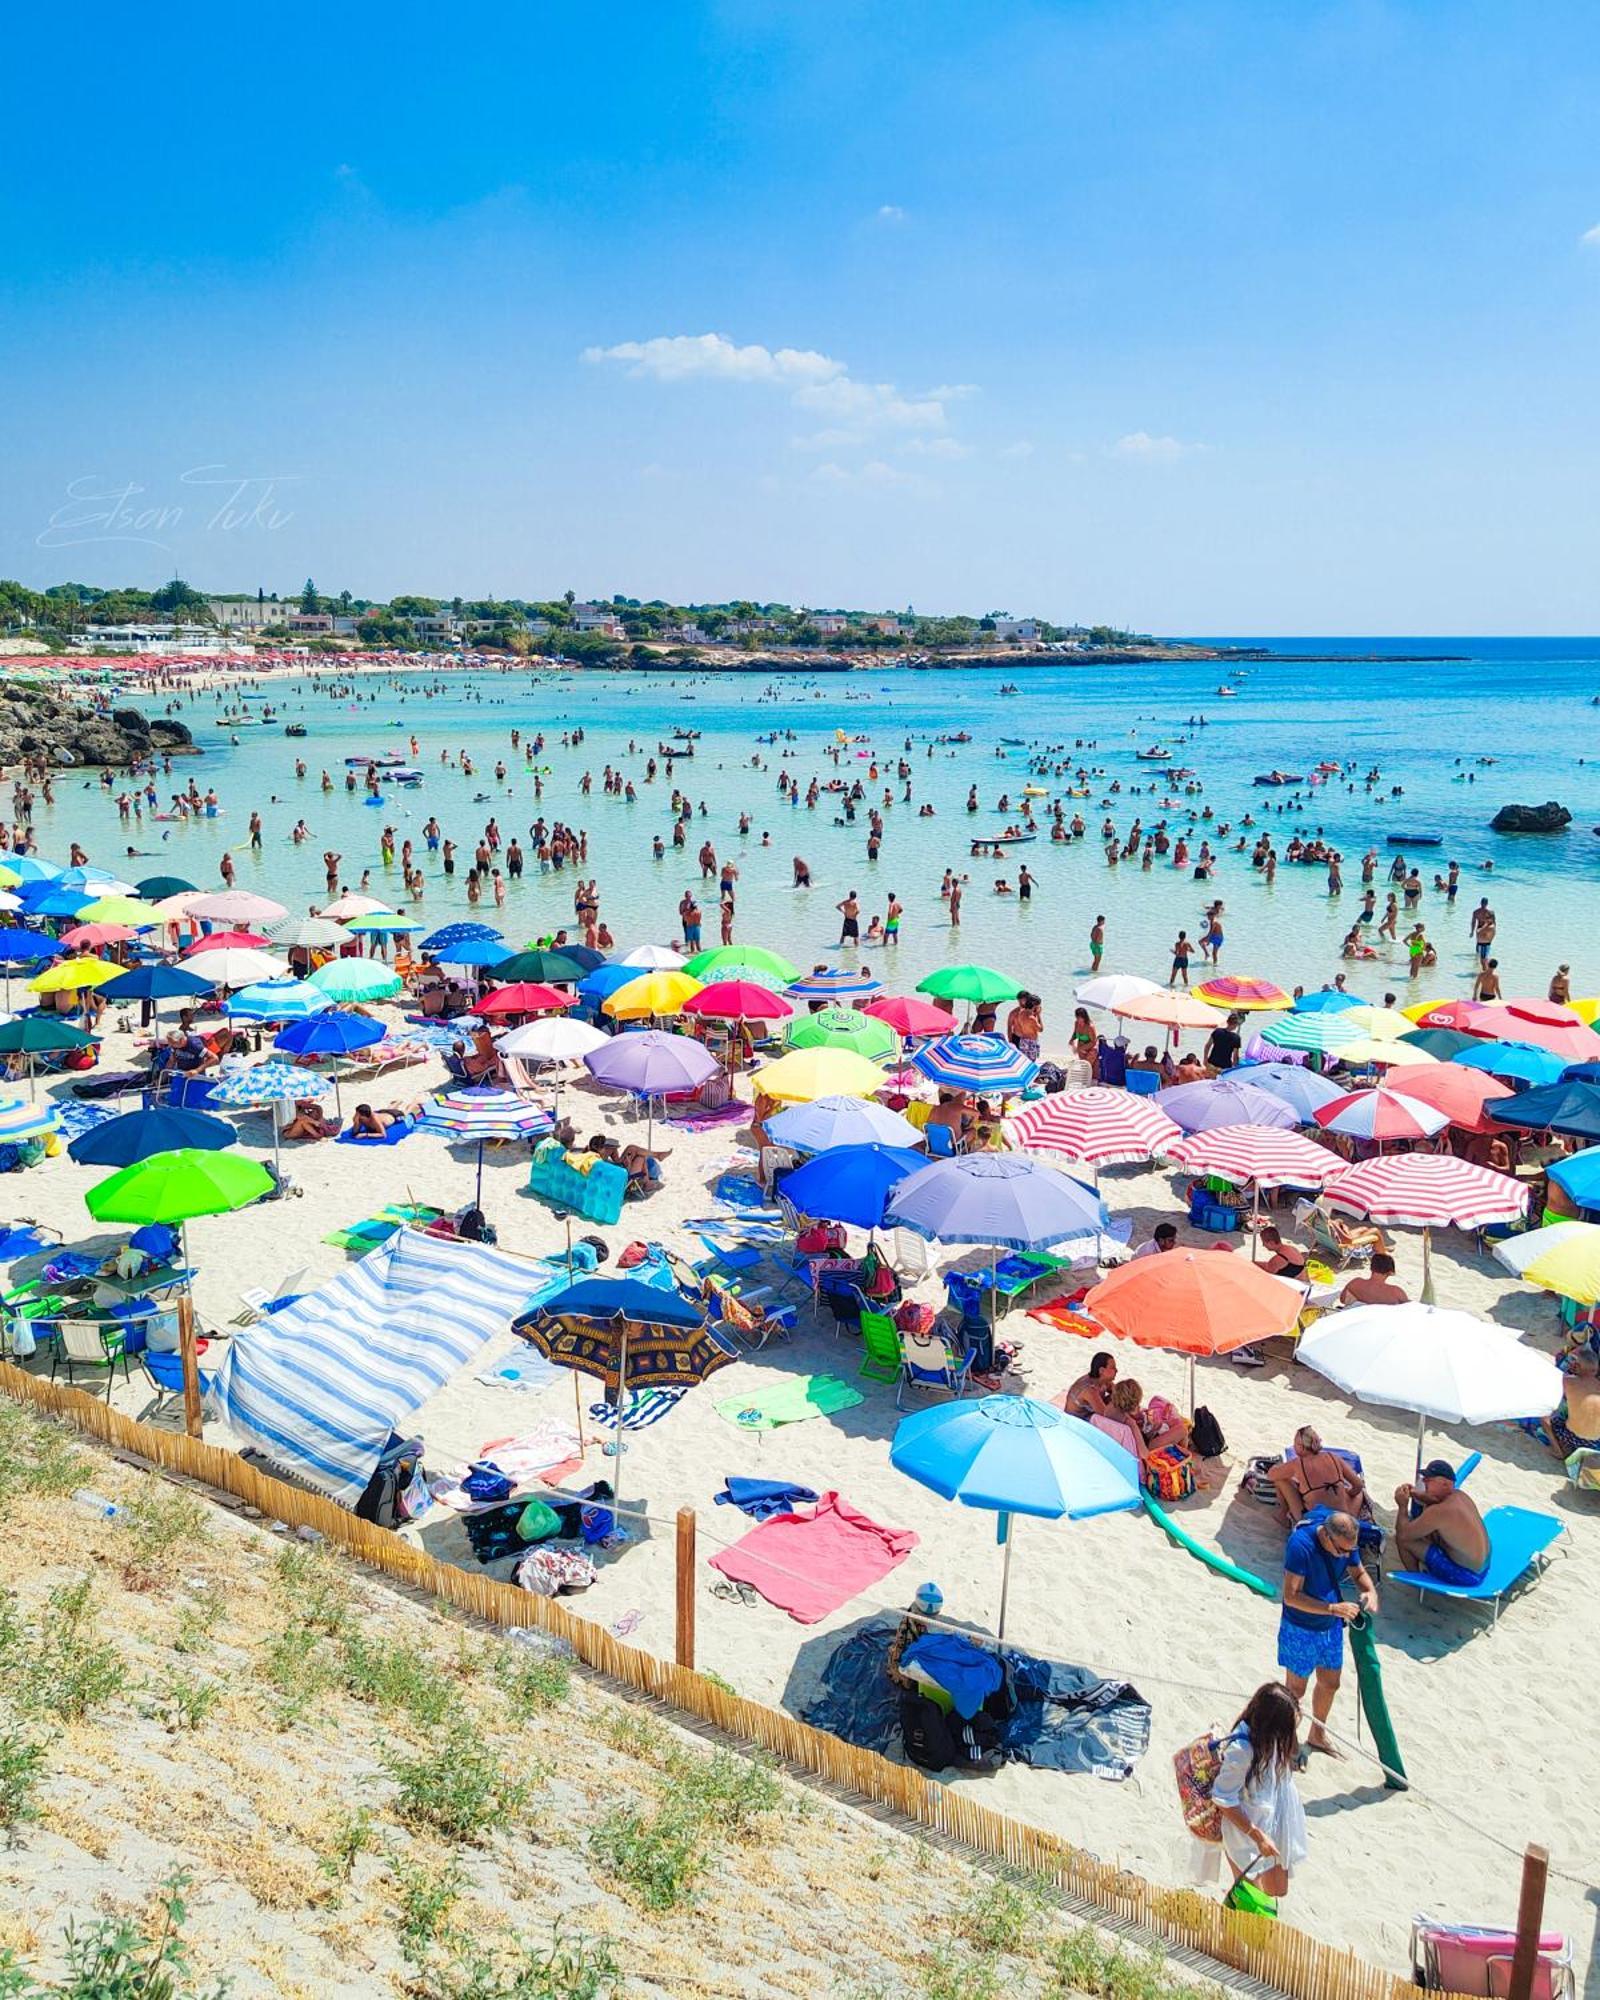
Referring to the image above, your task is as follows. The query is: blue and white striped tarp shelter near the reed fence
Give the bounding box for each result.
[216,1230,540,1506]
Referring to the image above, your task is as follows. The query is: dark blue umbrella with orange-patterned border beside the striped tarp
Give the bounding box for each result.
[512,1278,736,1508]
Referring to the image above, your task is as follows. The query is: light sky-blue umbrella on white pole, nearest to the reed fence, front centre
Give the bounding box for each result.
[888,1396,1144,1638]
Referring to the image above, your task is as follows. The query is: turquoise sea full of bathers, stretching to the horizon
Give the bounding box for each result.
[50,638,1600,1030]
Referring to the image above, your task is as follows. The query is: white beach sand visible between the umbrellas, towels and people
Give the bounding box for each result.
[6,1016,1600,1968]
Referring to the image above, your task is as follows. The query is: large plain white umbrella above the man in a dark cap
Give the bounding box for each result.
[1294,1302,1562,1466]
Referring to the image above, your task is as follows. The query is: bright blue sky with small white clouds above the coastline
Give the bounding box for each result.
[0,0,1600,632]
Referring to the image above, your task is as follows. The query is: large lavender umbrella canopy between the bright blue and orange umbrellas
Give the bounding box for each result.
[886,1152,1110,1250]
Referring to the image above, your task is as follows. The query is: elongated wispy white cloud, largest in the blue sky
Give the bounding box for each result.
[582,334,974,430]
